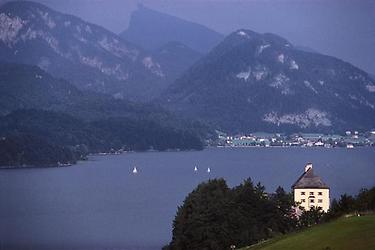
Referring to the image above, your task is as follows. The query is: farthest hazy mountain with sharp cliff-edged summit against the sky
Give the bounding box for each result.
[120,5,223,53]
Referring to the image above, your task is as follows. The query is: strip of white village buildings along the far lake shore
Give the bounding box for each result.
[217,130,375,148]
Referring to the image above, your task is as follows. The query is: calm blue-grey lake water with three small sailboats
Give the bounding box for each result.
[0,148,375,249]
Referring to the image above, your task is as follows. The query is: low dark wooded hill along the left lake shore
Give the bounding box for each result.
[0,110,203,166]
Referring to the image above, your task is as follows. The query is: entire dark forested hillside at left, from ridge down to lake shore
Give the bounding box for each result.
[0,63,212,166]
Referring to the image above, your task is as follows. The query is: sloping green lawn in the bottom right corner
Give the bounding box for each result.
[243,215,375,250]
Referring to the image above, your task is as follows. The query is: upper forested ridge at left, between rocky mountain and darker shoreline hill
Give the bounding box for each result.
[0,63,212,137]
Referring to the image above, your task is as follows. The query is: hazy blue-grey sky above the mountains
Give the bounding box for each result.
[0,0,375,73]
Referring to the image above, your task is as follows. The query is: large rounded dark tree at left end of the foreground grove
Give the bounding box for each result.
[170,179,234,250]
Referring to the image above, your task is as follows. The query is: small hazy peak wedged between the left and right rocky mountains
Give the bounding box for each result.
[152,42,203,83]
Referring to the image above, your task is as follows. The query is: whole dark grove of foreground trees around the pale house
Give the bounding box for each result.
[164,179,375,250]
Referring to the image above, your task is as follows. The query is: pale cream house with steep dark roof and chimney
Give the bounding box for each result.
[292,163,330,212]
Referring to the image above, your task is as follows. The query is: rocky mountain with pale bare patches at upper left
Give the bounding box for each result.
[0,1,167,101]
